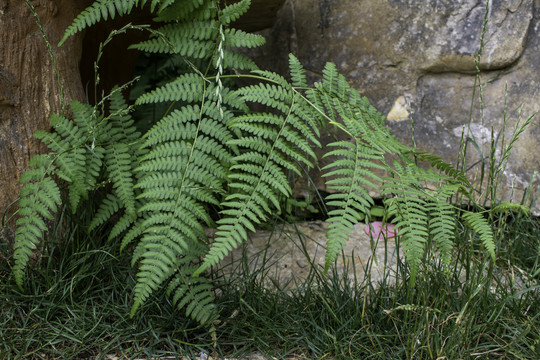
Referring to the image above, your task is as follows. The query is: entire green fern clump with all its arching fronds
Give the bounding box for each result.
[14,0,502,324]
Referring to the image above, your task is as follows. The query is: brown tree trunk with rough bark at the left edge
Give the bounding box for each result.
[0,0,88,226]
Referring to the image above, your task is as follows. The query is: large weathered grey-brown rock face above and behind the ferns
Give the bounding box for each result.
[250,0,540,213]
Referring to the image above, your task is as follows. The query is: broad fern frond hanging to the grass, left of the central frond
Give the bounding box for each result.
[130,96,233,312]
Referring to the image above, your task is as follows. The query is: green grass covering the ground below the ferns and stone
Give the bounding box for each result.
[0,207,540,359]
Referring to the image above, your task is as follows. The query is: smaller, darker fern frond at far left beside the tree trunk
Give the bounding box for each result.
[14,90,139,286]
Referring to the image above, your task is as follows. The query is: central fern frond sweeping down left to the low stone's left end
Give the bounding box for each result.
[194,61,320,276]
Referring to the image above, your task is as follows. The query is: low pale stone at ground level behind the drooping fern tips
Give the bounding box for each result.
[219,221,396,288]
